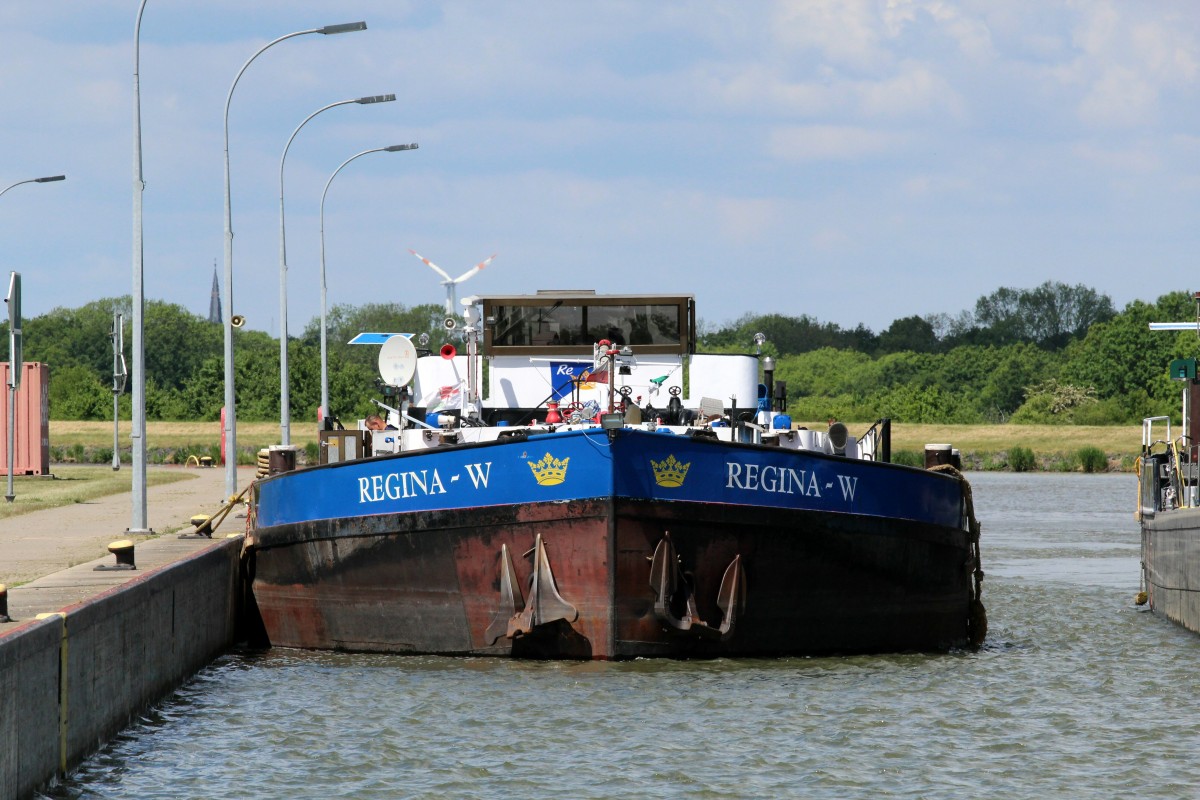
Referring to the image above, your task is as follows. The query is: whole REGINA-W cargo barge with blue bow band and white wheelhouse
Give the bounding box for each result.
[245,290,986,660]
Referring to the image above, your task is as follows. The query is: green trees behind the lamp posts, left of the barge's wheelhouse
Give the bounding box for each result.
[4,296,443,425]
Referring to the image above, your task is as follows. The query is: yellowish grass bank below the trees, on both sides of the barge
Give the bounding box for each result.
[50,421,1141,471]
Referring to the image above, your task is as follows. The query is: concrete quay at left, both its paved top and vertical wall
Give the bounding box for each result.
[0,468,254,799]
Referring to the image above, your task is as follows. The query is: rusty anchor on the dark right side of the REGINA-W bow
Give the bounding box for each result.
[650,533,746,642]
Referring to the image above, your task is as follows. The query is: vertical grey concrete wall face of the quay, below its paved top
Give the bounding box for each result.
[0,539,241,798]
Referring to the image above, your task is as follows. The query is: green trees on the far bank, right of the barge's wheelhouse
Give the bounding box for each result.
[701,282,1200,425]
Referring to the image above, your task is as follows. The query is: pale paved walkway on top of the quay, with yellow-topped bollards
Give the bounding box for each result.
[0,467,254,618]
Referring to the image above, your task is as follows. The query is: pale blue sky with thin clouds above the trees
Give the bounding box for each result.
[0,0,1200,333]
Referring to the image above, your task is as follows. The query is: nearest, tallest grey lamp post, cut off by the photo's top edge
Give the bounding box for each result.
[129,0,150,534]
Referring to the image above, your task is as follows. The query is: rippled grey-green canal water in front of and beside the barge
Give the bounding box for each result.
[43,473,1200,800]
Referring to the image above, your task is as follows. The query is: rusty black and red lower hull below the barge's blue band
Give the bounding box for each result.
[247,498,972,658]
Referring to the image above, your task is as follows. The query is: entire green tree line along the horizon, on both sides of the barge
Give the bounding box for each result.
[9,282,1200,425]
